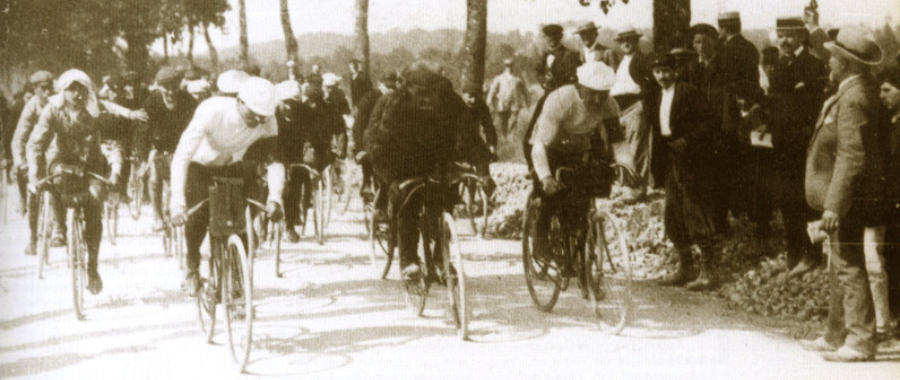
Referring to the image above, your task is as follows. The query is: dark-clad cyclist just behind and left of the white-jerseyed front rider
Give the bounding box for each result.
[144,67,197,231]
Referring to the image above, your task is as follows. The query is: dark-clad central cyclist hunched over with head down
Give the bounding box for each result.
[366,63,470,281]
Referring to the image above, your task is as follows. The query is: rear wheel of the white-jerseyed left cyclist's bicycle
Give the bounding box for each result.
[197,238,224,344]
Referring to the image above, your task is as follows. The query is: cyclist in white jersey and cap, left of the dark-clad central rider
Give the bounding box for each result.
[170,77,284,296]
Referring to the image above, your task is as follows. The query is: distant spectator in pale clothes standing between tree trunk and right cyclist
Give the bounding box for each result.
[486,58,528,136]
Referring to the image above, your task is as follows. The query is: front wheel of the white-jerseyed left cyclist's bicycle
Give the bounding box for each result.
[222,235,253,372]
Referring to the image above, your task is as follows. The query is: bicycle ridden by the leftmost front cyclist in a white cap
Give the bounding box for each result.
[35,164,112,321]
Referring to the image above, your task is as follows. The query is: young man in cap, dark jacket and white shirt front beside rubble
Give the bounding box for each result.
[647,54,716,290]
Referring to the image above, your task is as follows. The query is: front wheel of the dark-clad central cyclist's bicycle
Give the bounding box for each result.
[441,212,472,340]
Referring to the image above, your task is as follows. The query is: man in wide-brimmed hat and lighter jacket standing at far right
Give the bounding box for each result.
[801,27,886,362]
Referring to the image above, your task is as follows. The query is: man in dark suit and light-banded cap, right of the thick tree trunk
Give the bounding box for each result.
[710,12,759,230]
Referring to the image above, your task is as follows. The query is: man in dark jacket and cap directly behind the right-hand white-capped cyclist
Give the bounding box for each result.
[522,24,581,167]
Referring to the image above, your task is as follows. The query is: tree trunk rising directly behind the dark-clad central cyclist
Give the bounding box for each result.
[462,0,487,93]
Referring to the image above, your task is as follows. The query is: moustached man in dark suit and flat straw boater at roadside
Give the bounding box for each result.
[769,17,828,277]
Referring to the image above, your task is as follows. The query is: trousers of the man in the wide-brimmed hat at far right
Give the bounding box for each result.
[825,214,875,354]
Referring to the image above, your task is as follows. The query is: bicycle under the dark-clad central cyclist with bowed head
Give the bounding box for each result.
[385,168,472,340]
